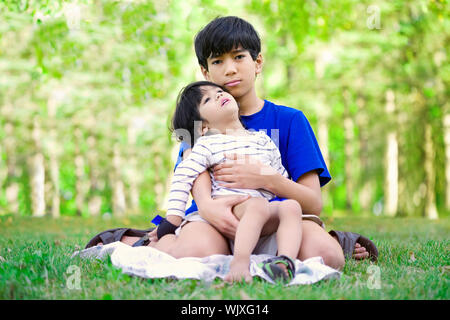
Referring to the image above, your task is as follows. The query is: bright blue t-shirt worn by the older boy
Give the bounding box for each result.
[175,100,331,214]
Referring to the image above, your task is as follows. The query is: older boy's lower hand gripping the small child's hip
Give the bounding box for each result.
[198,196,250,239]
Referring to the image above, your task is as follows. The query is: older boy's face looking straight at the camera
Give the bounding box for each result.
[201,46,263,99]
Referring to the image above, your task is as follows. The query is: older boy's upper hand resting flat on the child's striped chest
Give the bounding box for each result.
[214,153,277,190]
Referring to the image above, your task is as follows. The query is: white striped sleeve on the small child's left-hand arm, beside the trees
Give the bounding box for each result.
[166,139,212,218]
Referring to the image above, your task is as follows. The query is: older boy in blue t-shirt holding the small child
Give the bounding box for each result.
[171,17,378,269]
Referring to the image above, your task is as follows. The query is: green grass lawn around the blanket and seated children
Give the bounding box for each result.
[0,216,450,300]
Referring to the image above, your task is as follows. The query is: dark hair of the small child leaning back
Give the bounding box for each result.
[170,81,228,146]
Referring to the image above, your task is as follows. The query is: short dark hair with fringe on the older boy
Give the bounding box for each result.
[195,16,261,70]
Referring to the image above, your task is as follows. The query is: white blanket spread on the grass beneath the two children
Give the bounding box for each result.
[72,241,341,285]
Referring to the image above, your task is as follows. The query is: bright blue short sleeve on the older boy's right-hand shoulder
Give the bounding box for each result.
[286,112,331,187]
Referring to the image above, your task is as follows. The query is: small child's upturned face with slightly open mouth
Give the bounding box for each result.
[198,86,239,129]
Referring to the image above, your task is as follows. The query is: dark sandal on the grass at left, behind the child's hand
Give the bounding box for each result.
[85,228,155,249]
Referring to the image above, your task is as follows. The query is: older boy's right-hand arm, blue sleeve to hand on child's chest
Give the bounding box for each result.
[215,112,331,215]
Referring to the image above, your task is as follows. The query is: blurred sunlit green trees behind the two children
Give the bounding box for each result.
[0,0,450,219]
